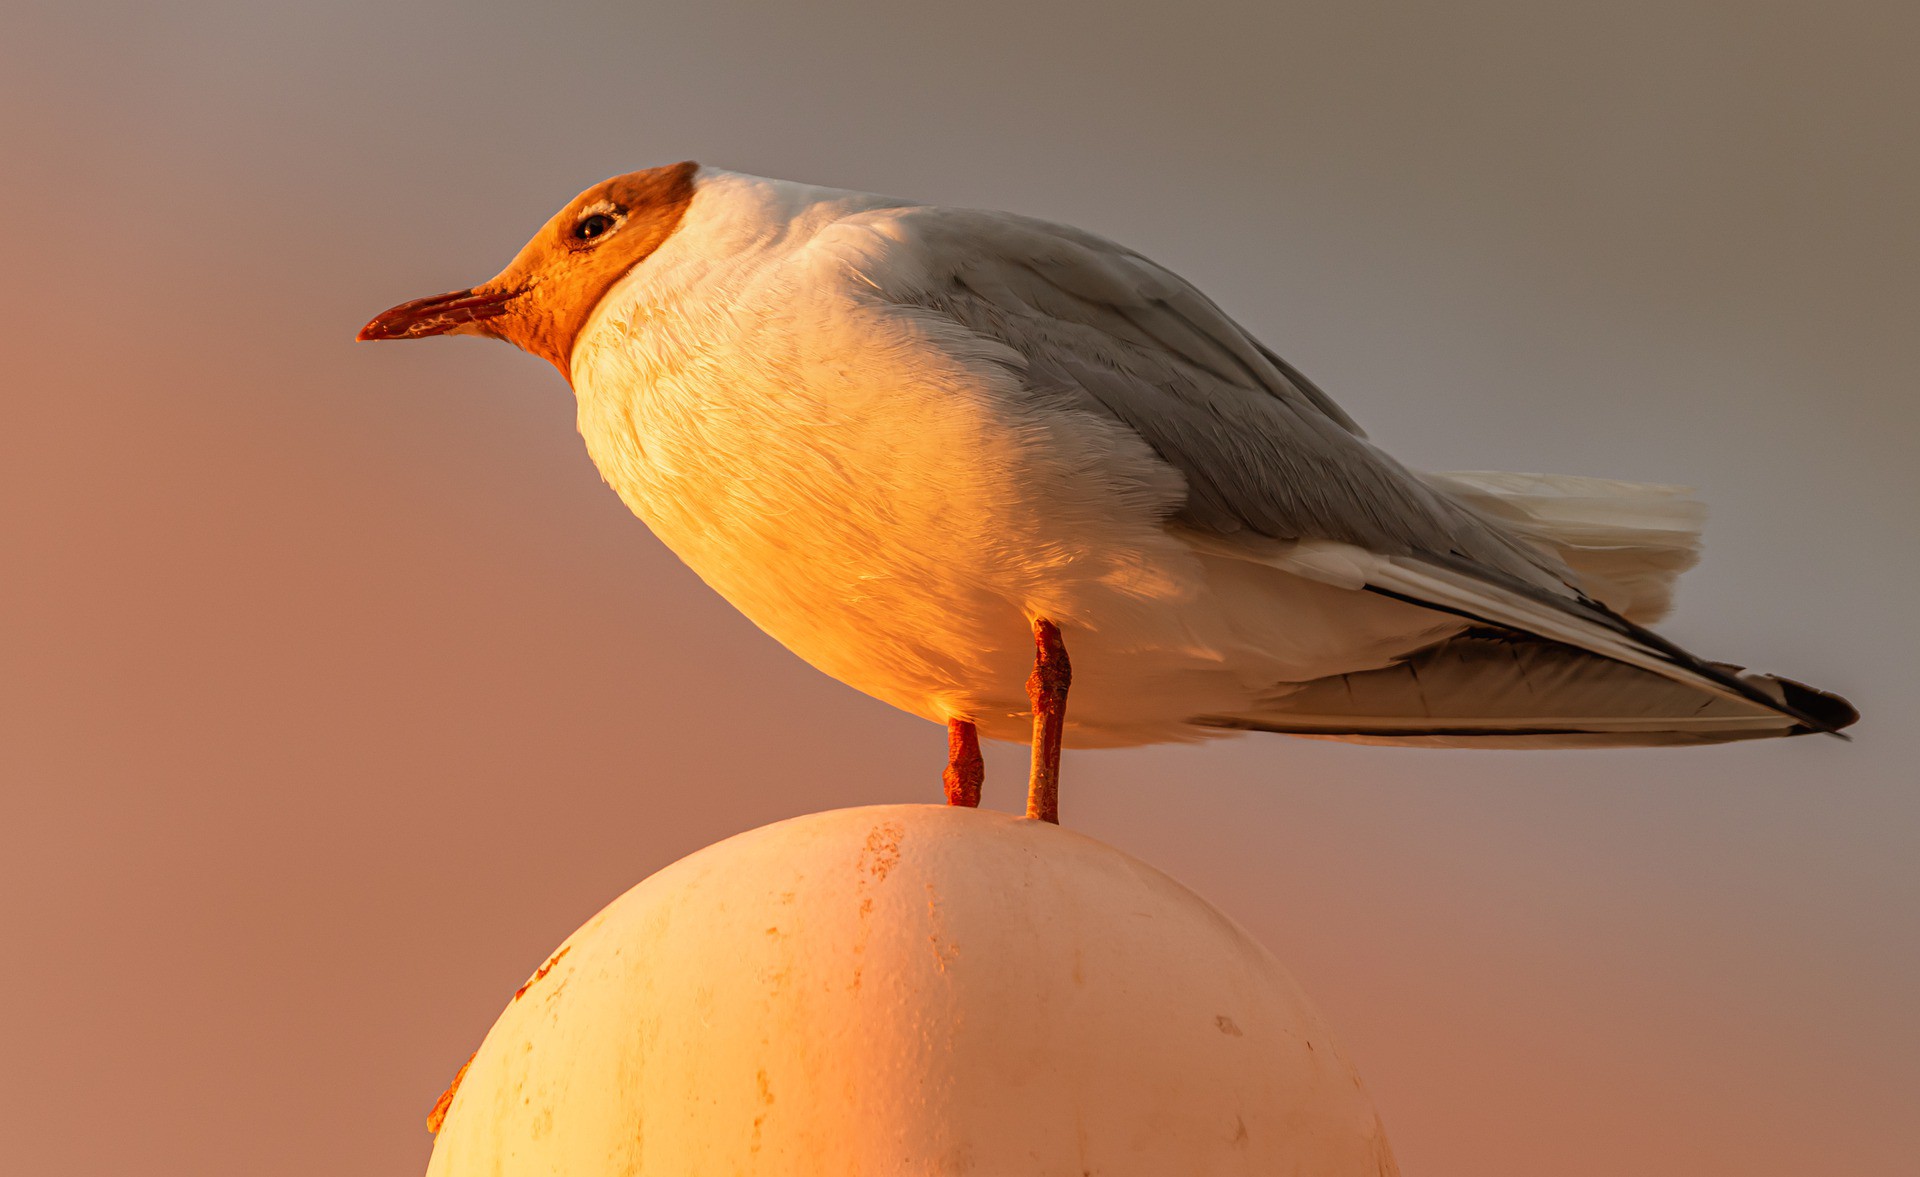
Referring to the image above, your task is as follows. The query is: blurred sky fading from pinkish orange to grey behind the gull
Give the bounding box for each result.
[0,0,1920,1177]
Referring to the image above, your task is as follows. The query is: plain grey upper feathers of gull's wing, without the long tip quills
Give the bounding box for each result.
[879,209,1571,591]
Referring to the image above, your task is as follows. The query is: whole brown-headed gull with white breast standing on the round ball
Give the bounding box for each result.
[359,163,1859,822]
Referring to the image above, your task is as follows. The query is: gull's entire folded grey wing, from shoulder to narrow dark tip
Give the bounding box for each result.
[870,207,1830,730]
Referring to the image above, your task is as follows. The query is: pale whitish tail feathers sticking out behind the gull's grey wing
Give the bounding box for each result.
[1425,470,1707,626]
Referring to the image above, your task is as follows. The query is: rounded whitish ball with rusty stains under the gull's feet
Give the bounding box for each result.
[428,805,1398,1177]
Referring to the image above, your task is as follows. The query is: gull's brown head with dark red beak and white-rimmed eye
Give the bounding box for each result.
[359,163,699,376]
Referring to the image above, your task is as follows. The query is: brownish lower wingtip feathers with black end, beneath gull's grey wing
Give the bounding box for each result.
[1194,630,1859,749]
